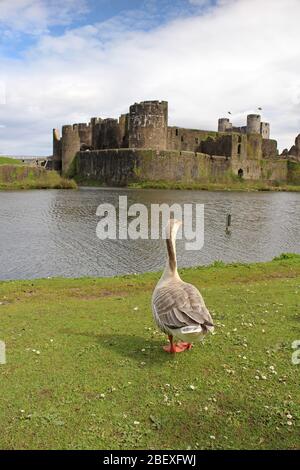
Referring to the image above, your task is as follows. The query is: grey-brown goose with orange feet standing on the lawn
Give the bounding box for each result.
[152,219,214,353]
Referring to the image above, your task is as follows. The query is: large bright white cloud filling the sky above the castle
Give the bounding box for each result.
[0,0,300,154]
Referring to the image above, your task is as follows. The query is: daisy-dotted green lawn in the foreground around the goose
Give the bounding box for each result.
[0,255,300,449]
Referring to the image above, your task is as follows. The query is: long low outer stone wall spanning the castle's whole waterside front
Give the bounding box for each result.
[69,149,300,186]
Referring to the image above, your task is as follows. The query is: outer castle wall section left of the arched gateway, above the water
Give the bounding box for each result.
[70,149,230,186]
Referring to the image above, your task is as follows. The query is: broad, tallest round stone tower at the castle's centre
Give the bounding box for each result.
[129,101,168,150]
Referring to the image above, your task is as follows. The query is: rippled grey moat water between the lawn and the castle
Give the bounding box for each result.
[0,188,300,279]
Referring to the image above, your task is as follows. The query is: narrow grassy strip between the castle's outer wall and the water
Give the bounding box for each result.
[129,180,300,192]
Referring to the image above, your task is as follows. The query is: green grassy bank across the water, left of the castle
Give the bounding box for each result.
[0,164,77,190]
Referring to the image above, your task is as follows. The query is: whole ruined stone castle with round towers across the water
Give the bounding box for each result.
[51,101,300,185]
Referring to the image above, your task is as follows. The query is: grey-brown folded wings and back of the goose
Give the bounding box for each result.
[153,282,213,330]
